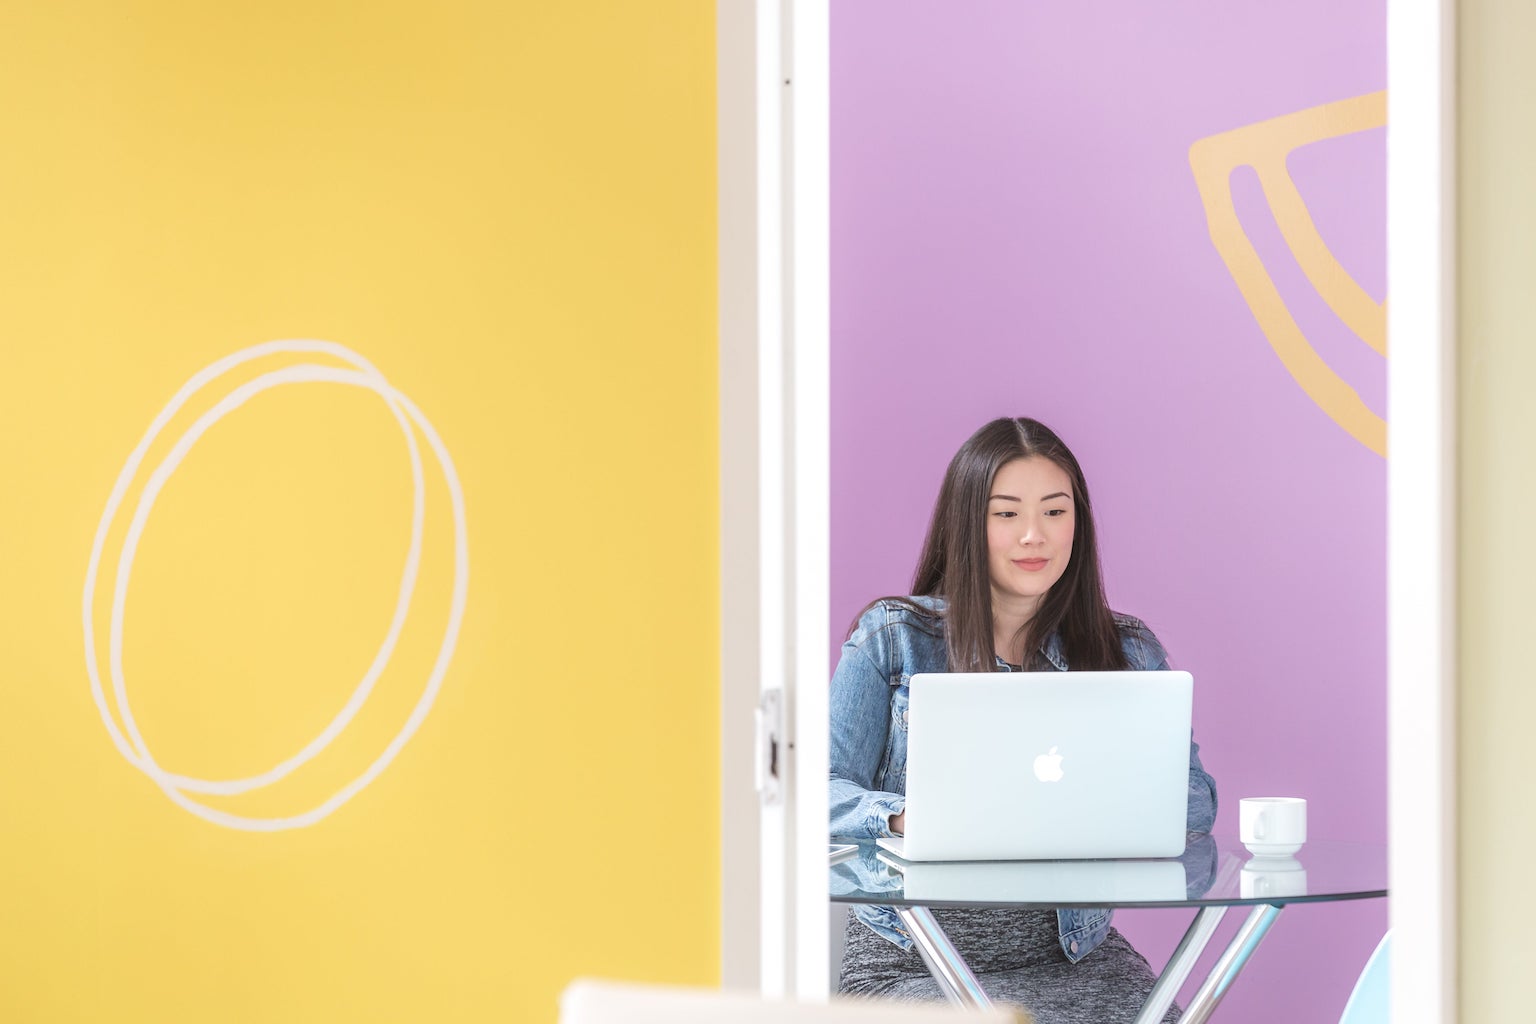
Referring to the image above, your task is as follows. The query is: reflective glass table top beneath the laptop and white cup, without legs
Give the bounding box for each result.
[829,835,1387,907]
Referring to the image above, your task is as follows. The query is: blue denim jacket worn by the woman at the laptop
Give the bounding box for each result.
[828,597,1217,963]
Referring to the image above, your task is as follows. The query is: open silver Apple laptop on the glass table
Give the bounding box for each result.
[879,672,1193,861]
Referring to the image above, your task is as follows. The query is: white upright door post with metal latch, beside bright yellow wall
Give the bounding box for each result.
[716,0,831,999]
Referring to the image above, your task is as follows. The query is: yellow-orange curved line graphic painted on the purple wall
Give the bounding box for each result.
[1189,92,1387,456]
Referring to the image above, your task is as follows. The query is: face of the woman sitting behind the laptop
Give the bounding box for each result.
[986,456,1077,616]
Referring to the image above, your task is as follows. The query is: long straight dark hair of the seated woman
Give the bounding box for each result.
[884,416,1126,672]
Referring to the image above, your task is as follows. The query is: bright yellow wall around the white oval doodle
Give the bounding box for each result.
[0,0,719,1022]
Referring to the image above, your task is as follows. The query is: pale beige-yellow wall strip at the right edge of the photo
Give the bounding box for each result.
[1458,0,1536,1021]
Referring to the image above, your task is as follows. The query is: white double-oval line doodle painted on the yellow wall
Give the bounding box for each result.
[84,341,468,832]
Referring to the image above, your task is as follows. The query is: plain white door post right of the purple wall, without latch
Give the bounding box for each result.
[1387,0,1458,1024]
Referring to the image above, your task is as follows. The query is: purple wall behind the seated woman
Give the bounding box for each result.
[831,0,1387,1024]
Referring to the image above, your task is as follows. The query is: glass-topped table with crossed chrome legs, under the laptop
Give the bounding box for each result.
[829,835,1387,1024]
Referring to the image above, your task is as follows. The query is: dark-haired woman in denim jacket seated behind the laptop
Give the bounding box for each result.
[829,419,1217,1024]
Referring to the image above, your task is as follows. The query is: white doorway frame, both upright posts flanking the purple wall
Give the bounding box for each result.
[716,0,1456,1024]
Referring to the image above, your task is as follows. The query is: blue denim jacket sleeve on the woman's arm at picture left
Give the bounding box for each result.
[828,605,906,838]
